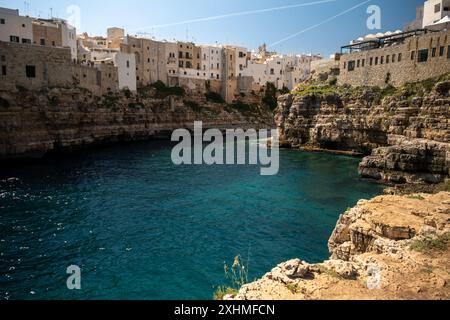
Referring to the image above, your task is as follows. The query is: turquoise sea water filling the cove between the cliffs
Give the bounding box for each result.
[0,142,382,299]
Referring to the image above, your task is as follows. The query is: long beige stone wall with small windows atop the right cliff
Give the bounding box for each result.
[338,31,450,86]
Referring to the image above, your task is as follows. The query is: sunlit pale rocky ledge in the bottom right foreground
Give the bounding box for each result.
[229,192,450,300]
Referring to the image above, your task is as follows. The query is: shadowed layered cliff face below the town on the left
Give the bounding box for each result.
[0,88,274,160]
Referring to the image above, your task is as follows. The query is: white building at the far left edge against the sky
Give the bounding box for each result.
[0,8,33,44]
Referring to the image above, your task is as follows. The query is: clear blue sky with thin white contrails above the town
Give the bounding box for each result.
[0,0,424,56]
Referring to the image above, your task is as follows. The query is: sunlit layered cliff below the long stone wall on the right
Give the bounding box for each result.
[275,83,450,183]
